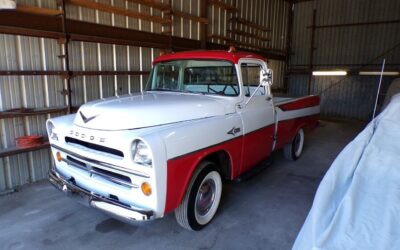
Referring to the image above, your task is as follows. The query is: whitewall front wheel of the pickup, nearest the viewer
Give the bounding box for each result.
[175,162,222,231]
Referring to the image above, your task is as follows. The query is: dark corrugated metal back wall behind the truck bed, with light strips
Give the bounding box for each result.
[288,0,400,120]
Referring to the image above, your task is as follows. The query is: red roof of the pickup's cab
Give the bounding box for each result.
[153,50,265,64]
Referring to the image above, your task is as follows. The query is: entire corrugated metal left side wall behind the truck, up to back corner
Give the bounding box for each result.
[0,0,289,192]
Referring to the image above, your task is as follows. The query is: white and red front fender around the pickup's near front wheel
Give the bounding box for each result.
[158,114,243,213]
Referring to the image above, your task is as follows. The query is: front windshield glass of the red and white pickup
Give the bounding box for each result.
[146,60,239,96]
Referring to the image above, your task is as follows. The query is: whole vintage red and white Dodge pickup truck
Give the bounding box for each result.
[46,51,320,230]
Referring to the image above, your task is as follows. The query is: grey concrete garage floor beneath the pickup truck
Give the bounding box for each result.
[0,121,363,249]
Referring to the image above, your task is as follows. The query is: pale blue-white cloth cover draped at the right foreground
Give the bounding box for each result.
[293,94,400,250]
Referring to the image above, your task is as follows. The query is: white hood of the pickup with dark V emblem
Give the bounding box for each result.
[74,92,233,130]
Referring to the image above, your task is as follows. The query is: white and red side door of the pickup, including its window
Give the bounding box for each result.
[238,60,275,173]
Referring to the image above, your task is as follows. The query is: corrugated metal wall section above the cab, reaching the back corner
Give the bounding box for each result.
[208,0,290,89]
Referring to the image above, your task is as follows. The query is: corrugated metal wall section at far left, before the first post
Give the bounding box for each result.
[0,34,66,191]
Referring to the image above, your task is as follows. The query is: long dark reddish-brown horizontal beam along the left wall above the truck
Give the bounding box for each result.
[0,11,286,61]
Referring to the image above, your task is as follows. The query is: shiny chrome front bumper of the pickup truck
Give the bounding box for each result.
[49,170,154,224]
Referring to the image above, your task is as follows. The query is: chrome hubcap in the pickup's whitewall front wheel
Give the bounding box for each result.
[196,179,216,216]
